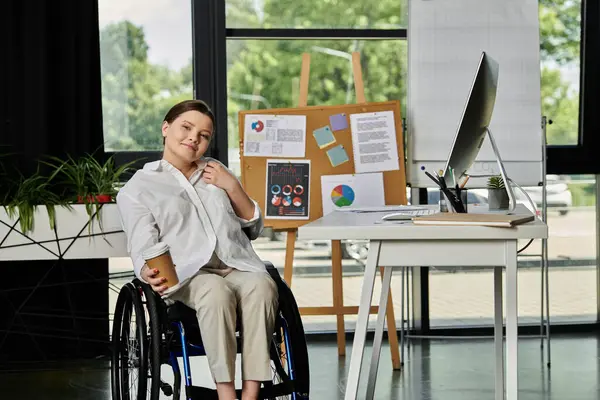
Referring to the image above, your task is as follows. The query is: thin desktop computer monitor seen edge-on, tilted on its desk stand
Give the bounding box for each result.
[443,52,516,210]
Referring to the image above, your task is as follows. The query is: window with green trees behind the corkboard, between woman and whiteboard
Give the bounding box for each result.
[226,0,408,331]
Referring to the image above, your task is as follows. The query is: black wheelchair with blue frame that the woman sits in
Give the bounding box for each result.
[111,262,309,400]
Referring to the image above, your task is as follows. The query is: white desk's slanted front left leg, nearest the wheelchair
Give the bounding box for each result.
[344,240,386,400]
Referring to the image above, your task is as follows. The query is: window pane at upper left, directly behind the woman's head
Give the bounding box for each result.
[98,0,193,152]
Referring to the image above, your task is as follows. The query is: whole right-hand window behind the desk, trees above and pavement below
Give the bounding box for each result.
[429,0,597,328]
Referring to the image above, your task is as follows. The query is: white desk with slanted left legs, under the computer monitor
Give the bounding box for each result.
[298,205,548,400]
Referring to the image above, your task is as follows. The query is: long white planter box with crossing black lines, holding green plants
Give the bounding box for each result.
[0,204,129,261]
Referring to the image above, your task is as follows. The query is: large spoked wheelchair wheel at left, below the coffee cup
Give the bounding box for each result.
[111,284,160,400]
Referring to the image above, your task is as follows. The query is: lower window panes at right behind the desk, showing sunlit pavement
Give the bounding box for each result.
[429,175,597,328]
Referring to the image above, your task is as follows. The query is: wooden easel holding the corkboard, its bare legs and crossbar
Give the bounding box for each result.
[283,52,401,370]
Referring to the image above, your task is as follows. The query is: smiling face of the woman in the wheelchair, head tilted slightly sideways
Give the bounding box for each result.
[162,111,213,163]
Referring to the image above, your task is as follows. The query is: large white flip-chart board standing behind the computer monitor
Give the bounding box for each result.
[407,0,543,187]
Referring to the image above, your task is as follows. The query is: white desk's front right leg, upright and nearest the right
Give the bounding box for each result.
[505,240,519,400]
